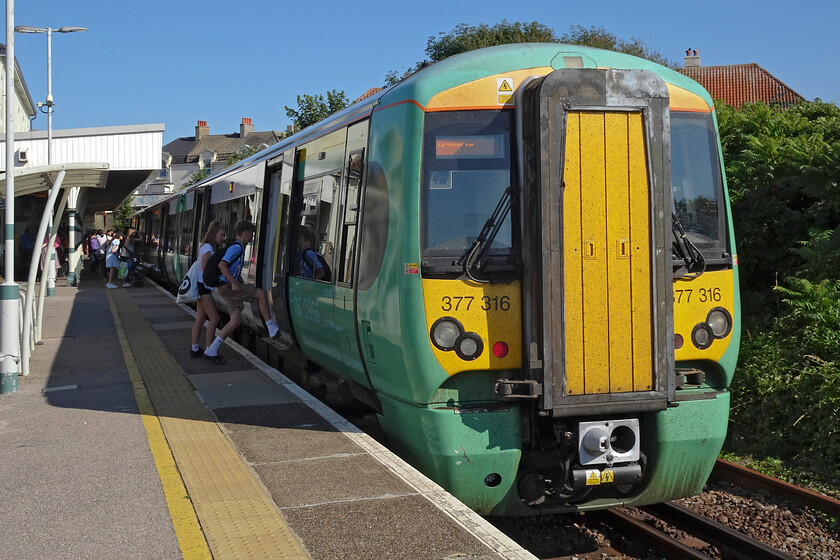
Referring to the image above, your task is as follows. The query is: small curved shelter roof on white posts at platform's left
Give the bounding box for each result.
[0,163,109,198]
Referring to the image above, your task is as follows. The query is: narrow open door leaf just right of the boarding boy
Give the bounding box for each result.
[266,150,295,350]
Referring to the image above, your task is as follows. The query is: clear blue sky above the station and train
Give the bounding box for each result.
[2,0,840,143]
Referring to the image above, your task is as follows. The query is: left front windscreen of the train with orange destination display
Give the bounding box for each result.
[422,111,516,271]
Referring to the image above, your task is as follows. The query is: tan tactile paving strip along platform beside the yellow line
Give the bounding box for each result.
[108,290,309,560]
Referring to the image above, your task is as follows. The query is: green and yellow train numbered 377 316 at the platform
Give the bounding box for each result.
[137,44,740,515]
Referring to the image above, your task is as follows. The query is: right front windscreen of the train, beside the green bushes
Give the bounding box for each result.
[671,111,725,249]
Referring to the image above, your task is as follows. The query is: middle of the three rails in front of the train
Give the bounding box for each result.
[641,502,795,560]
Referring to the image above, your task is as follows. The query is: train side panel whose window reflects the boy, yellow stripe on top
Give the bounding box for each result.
[288,129,347,377]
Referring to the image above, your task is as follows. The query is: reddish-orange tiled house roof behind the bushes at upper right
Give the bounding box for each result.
[679,63,804,107]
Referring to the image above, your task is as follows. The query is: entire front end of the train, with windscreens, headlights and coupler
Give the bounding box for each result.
[392,63,737,515]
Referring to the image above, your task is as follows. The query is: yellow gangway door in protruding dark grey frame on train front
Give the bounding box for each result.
[517,68,674,416]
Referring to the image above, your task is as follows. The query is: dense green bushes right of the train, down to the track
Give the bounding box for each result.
[716,101,840,489]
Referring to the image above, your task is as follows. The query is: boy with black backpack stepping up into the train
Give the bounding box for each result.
[204,220,280,364]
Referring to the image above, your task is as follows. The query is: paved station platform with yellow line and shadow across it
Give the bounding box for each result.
[0,275,535,560]
